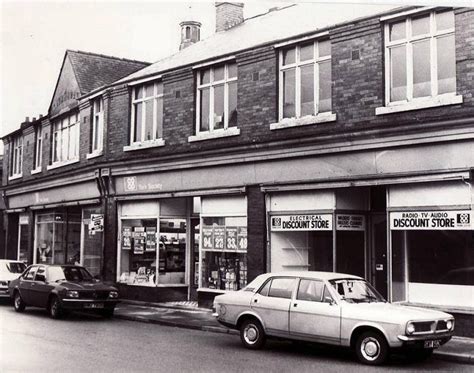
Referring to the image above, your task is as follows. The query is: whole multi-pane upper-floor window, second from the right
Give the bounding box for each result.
[279,40,331,120]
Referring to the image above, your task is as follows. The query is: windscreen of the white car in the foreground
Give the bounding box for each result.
[330,279,385,303]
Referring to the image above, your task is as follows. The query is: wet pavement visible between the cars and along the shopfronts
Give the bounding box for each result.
[115,300,474,365]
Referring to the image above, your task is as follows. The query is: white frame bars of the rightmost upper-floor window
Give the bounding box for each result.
[384,11,457,106]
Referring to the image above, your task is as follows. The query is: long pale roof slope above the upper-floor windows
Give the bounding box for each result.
[117,3,400,83]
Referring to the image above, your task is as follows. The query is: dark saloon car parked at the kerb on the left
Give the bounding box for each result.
[8,264,118,319]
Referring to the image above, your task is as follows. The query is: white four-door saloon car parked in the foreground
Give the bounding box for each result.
[214,272,454,365]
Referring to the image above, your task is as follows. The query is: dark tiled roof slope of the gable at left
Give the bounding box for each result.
[66,50,150,94]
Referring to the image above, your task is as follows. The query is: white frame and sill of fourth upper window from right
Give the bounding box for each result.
[130,80,164,150]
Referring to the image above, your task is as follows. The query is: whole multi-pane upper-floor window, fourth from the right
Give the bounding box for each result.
[130,82,163,144]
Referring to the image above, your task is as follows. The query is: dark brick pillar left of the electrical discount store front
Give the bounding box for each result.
[247,186,266,282]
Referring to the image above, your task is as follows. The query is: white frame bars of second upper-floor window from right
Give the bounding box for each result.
[278,39,332,122]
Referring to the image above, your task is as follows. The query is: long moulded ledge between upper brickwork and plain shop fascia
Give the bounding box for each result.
[110,129,474,175]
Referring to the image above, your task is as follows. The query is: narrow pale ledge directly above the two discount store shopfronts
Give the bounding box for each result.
[260,171,469,193]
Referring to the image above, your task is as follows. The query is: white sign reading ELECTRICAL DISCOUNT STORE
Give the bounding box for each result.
[271,214,332,231]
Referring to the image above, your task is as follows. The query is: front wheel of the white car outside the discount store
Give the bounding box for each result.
[355,331,388,365]
